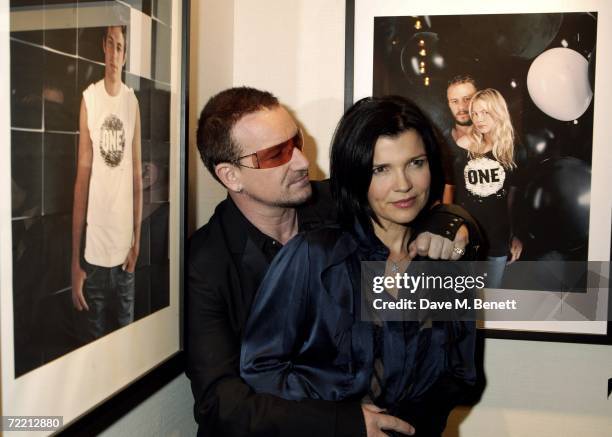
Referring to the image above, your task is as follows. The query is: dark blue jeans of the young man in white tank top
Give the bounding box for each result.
[82,261,135,342]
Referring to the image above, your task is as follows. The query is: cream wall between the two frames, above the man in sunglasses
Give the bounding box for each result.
[234,0,344,179]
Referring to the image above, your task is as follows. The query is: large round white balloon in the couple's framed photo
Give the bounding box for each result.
[527,47,593,121]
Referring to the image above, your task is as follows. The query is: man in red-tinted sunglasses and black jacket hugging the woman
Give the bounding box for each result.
[186,88,474,437]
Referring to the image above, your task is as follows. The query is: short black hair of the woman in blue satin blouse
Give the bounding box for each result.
[330,96,444,229]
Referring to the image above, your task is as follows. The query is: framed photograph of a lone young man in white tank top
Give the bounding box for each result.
[0,0,188,435]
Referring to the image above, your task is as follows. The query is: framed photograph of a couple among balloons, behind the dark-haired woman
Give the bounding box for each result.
[345,0,612,344]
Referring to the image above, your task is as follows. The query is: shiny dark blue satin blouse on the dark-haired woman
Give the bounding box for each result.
[240,225,476,407]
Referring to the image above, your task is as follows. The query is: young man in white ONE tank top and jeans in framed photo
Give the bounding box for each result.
[72,26,143,342]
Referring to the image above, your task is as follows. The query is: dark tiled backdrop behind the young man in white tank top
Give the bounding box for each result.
[10,0,172,377]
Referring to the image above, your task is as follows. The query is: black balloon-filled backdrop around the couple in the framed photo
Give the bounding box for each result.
[372,13,597,261]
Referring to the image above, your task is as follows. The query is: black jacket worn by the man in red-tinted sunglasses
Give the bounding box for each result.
[185,183,365,437]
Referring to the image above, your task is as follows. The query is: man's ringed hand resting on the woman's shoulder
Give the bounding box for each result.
[408,225,470,261]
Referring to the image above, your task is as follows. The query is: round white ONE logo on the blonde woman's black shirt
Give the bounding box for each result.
[463,157,506,197]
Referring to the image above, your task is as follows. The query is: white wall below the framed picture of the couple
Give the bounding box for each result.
[444,339,612,437]
